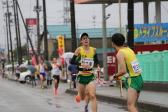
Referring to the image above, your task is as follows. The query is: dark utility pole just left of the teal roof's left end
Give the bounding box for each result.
[43,0,48,60]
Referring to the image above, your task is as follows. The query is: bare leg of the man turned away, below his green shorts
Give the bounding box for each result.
[127,87,138,112]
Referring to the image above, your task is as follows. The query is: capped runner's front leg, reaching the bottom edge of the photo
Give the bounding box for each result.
[88,81,97,112]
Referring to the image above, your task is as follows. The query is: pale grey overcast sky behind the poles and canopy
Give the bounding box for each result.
[0,0,168,48]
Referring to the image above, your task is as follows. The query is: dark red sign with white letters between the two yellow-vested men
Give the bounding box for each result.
[107,53,118,75]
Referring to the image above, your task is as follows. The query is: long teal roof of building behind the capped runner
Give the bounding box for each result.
[47,25,124,39]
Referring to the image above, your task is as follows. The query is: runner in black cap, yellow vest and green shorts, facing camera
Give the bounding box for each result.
[71,33,100,112]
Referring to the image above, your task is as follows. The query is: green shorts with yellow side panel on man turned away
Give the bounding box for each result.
[125,75,143,93]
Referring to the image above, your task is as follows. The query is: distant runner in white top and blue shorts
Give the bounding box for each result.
[39,59,47,89]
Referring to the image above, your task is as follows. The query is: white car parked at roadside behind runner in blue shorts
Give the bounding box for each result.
[19,68,31,83]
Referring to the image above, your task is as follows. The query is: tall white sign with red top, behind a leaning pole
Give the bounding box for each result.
[26,18,38,54]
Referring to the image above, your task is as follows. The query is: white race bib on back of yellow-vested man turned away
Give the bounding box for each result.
[131,60,142,74]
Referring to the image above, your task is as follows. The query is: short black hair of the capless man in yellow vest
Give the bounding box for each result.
[111,33,125,46]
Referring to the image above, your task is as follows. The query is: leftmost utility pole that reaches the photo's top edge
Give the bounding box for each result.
[7,0,14,72]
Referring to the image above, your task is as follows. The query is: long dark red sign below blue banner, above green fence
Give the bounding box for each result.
[134,44,168,54]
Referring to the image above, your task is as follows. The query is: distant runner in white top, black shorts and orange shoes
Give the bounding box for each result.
[51,58,62,95]
